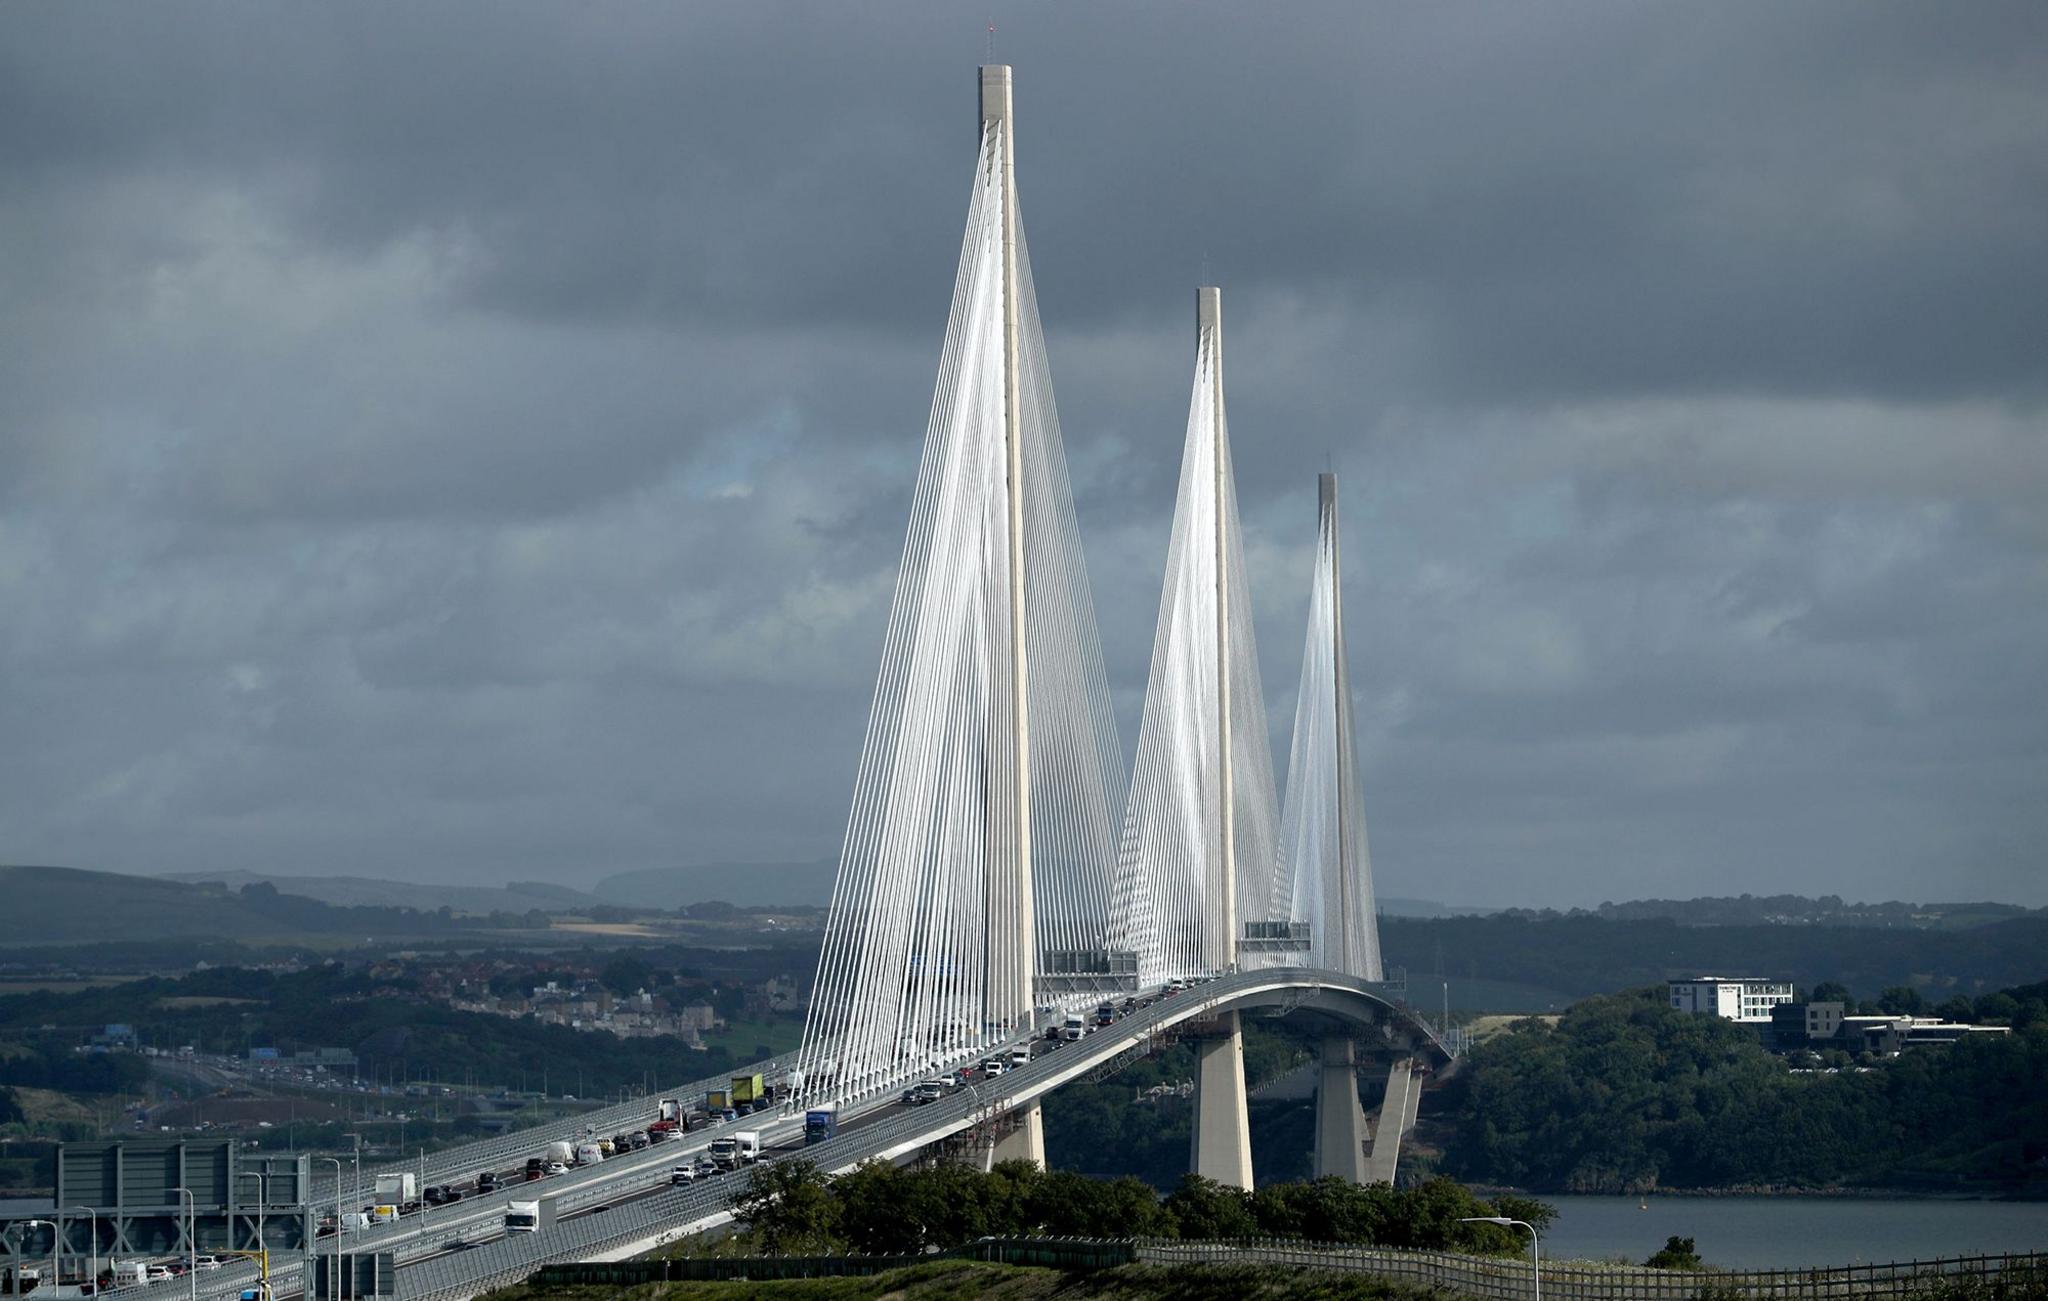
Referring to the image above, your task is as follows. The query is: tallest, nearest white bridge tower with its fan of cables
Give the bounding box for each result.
[797,68,1122,1100]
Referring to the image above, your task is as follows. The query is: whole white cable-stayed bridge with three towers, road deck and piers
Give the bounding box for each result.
[79,68,1452,1299]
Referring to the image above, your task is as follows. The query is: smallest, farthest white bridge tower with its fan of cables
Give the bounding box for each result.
[1280,473,1380,979]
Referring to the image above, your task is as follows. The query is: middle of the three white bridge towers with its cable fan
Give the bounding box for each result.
[1110,287,1278,983]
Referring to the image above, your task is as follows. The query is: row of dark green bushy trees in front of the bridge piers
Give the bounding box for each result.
[731,1160,1554,1256]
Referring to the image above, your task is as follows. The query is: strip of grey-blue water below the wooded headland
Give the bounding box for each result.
[1542,1197,2048,1270]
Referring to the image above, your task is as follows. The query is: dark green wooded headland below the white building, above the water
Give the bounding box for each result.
[1434,985,2048,1192]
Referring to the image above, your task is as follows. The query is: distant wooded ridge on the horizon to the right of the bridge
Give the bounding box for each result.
[1380,914,2048,1004]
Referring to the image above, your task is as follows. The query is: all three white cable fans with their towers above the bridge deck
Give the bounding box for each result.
[791,68,1380,1104]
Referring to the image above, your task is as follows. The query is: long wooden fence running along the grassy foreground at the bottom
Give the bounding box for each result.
[516,1237,2048,1301]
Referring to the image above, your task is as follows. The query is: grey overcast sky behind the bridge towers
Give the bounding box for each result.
[0,0,2048,906]
